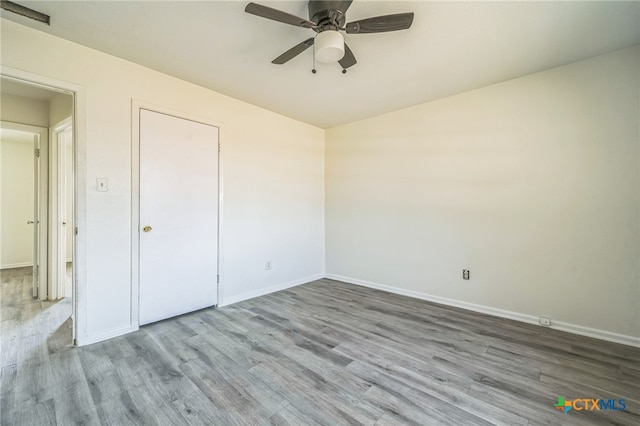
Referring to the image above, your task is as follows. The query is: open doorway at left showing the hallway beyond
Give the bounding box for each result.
[0,75,76,353]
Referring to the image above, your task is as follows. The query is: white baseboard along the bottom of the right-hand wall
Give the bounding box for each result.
[325,274,640,348]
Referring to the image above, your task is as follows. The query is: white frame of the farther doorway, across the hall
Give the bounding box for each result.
[0,121,49,300]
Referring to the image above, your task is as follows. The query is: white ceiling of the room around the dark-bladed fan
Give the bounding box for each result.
[2,0,640,128]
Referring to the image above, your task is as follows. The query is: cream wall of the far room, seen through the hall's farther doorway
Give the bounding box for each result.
[0,138,34,269]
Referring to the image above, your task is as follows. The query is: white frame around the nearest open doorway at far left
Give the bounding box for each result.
[0,65,89,346]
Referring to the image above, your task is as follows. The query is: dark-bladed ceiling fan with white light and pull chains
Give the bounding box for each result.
[244,0,413,73]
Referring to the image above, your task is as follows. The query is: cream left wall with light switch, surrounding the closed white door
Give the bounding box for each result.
[1,20,324,343]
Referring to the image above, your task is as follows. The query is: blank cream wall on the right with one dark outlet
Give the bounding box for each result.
[325,47,640,344]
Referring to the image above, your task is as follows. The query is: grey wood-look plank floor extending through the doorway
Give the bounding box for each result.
[0,270,640,426]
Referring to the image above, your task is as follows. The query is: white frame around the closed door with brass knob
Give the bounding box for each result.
[131,99,224,330]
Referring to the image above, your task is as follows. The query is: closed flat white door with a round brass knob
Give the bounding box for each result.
[139,109,218,325]
